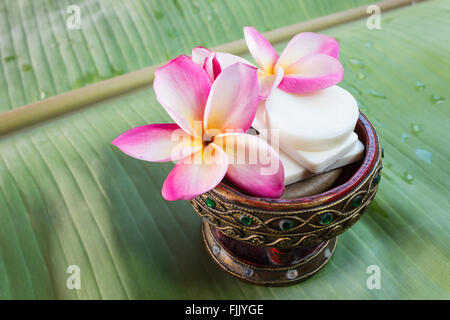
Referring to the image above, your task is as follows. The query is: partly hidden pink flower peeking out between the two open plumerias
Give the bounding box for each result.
[192,47,253,81]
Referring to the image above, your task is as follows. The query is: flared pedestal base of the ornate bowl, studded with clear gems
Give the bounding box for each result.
[202,221,337,286]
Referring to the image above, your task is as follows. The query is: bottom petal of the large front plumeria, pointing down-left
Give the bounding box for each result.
[162,143,228,200]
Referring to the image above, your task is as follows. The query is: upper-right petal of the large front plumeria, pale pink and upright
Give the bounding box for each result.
[203,63,258,132]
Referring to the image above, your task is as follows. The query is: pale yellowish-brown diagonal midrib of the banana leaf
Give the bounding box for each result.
[0,0,424,136]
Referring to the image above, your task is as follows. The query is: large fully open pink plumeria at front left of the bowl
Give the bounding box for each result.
[113,56,284,200]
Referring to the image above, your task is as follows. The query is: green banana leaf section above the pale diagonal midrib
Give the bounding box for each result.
[0,0,372,112]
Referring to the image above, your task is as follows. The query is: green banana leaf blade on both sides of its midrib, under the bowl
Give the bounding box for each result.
[0,0,450,299]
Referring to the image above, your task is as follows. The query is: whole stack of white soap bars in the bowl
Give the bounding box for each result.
[253,86,364,184]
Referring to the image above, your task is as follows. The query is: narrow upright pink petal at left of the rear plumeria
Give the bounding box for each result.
[244,27,278,74]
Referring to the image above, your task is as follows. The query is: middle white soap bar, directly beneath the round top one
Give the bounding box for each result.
[280,132,358,172]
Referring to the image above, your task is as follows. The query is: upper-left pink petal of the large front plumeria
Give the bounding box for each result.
[153,56,211,134]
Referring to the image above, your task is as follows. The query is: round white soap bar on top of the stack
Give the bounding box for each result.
[262,86,359,151]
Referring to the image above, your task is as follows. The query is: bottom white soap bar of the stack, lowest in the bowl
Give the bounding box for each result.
[279,140,364,186]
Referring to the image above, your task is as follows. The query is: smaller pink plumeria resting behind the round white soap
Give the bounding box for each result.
[244,27,344,98]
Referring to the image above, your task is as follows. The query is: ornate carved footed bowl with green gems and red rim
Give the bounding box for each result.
[191,114,382,286]
